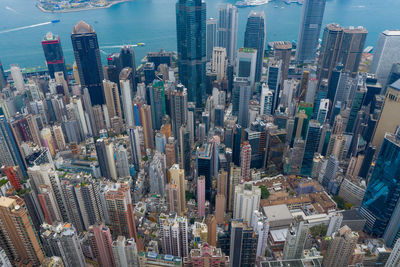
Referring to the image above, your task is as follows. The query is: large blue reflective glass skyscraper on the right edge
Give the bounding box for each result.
[360,130,400,246]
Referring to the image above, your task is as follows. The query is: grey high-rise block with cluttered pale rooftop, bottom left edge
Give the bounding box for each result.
[40,222,86,267]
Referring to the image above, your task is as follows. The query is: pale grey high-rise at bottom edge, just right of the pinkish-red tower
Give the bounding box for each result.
[112,236,138,267]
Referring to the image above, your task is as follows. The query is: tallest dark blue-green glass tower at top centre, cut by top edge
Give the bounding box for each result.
[176,0,206,107]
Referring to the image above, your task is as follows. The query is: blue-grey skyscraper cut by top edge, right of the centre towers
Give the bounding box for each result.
[296,0,326,63]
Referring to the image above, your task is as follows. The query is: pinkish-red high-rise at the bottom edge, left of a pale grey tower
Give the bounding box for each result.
[88,223,115,267]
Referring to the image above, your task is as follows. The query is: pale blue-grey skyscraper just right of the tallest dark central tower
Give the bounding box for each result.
[217,4,239,64]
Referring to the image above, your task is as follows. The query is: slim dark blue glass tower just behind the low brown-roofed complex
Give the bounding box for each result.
[300,121,321,175]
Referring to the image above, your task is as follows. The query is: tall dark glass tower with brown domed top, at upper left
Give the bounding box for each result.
[71,21,105,106]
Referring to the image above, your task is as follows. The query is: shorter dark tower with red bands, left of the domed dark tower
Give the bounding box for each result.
[42,32,67,80]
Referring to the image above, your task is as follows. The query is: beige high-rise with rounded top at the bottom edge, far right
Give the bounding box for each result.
[323,225,358,267]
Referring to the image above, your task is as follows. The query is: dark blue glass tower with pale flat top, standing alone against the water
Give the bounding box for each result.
[244,11,267,82]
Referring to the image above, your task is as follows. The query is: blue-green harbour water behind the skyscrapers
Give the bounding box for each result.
[0,0,400,69]
